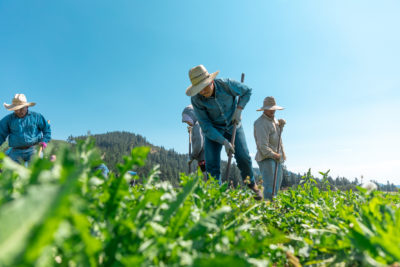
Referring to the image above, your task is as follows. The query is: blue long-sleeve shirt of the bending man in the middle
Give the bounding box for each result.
[191,79,251,144]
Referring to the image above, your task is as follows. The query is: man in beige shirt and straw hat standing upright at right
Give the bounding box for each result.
[254,96,286,199]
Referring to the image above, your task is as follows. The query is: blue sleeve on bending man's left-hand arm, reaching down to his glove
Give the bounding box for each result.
[191,97,225,145]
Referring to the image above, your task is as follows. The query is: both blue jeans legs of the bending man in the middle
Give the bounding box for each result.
[204,127,254,185]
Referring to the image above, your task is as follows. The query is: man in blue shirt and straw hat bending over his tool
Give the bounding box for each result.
[186,65,261,198]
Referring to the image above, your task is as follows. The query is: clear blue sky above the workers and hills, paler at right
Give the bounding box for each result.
[0,0,400,184]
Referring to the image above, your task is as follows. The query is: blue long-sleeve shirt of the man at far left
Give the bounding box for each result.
[0,109,51,147]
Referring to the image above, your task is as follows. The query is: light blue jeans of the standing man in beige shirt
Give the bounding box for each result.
[257,159,283,199]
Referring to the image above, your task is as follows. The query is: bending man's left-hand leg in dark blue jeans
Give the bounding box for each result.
[204,137,222,184]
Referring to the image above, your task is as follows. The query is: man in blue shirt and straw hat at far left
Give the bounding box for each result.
[0,94,51,165]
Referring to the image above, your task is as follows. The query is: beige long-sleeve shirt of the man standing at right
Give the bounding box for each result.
[254,114,285,161]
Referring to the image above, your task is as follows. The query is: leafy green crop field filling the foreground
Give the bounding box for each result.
[0,141,400,267]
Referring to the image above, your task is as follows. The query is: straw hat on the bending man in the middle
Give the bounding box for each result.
[186,65,219,96]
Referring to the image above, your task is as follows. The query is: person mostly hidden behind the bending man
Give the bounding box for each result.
[182,105,206,173]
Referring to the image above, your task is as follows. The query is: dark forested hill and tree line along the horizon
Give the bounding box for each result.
[0,131,398,192]
